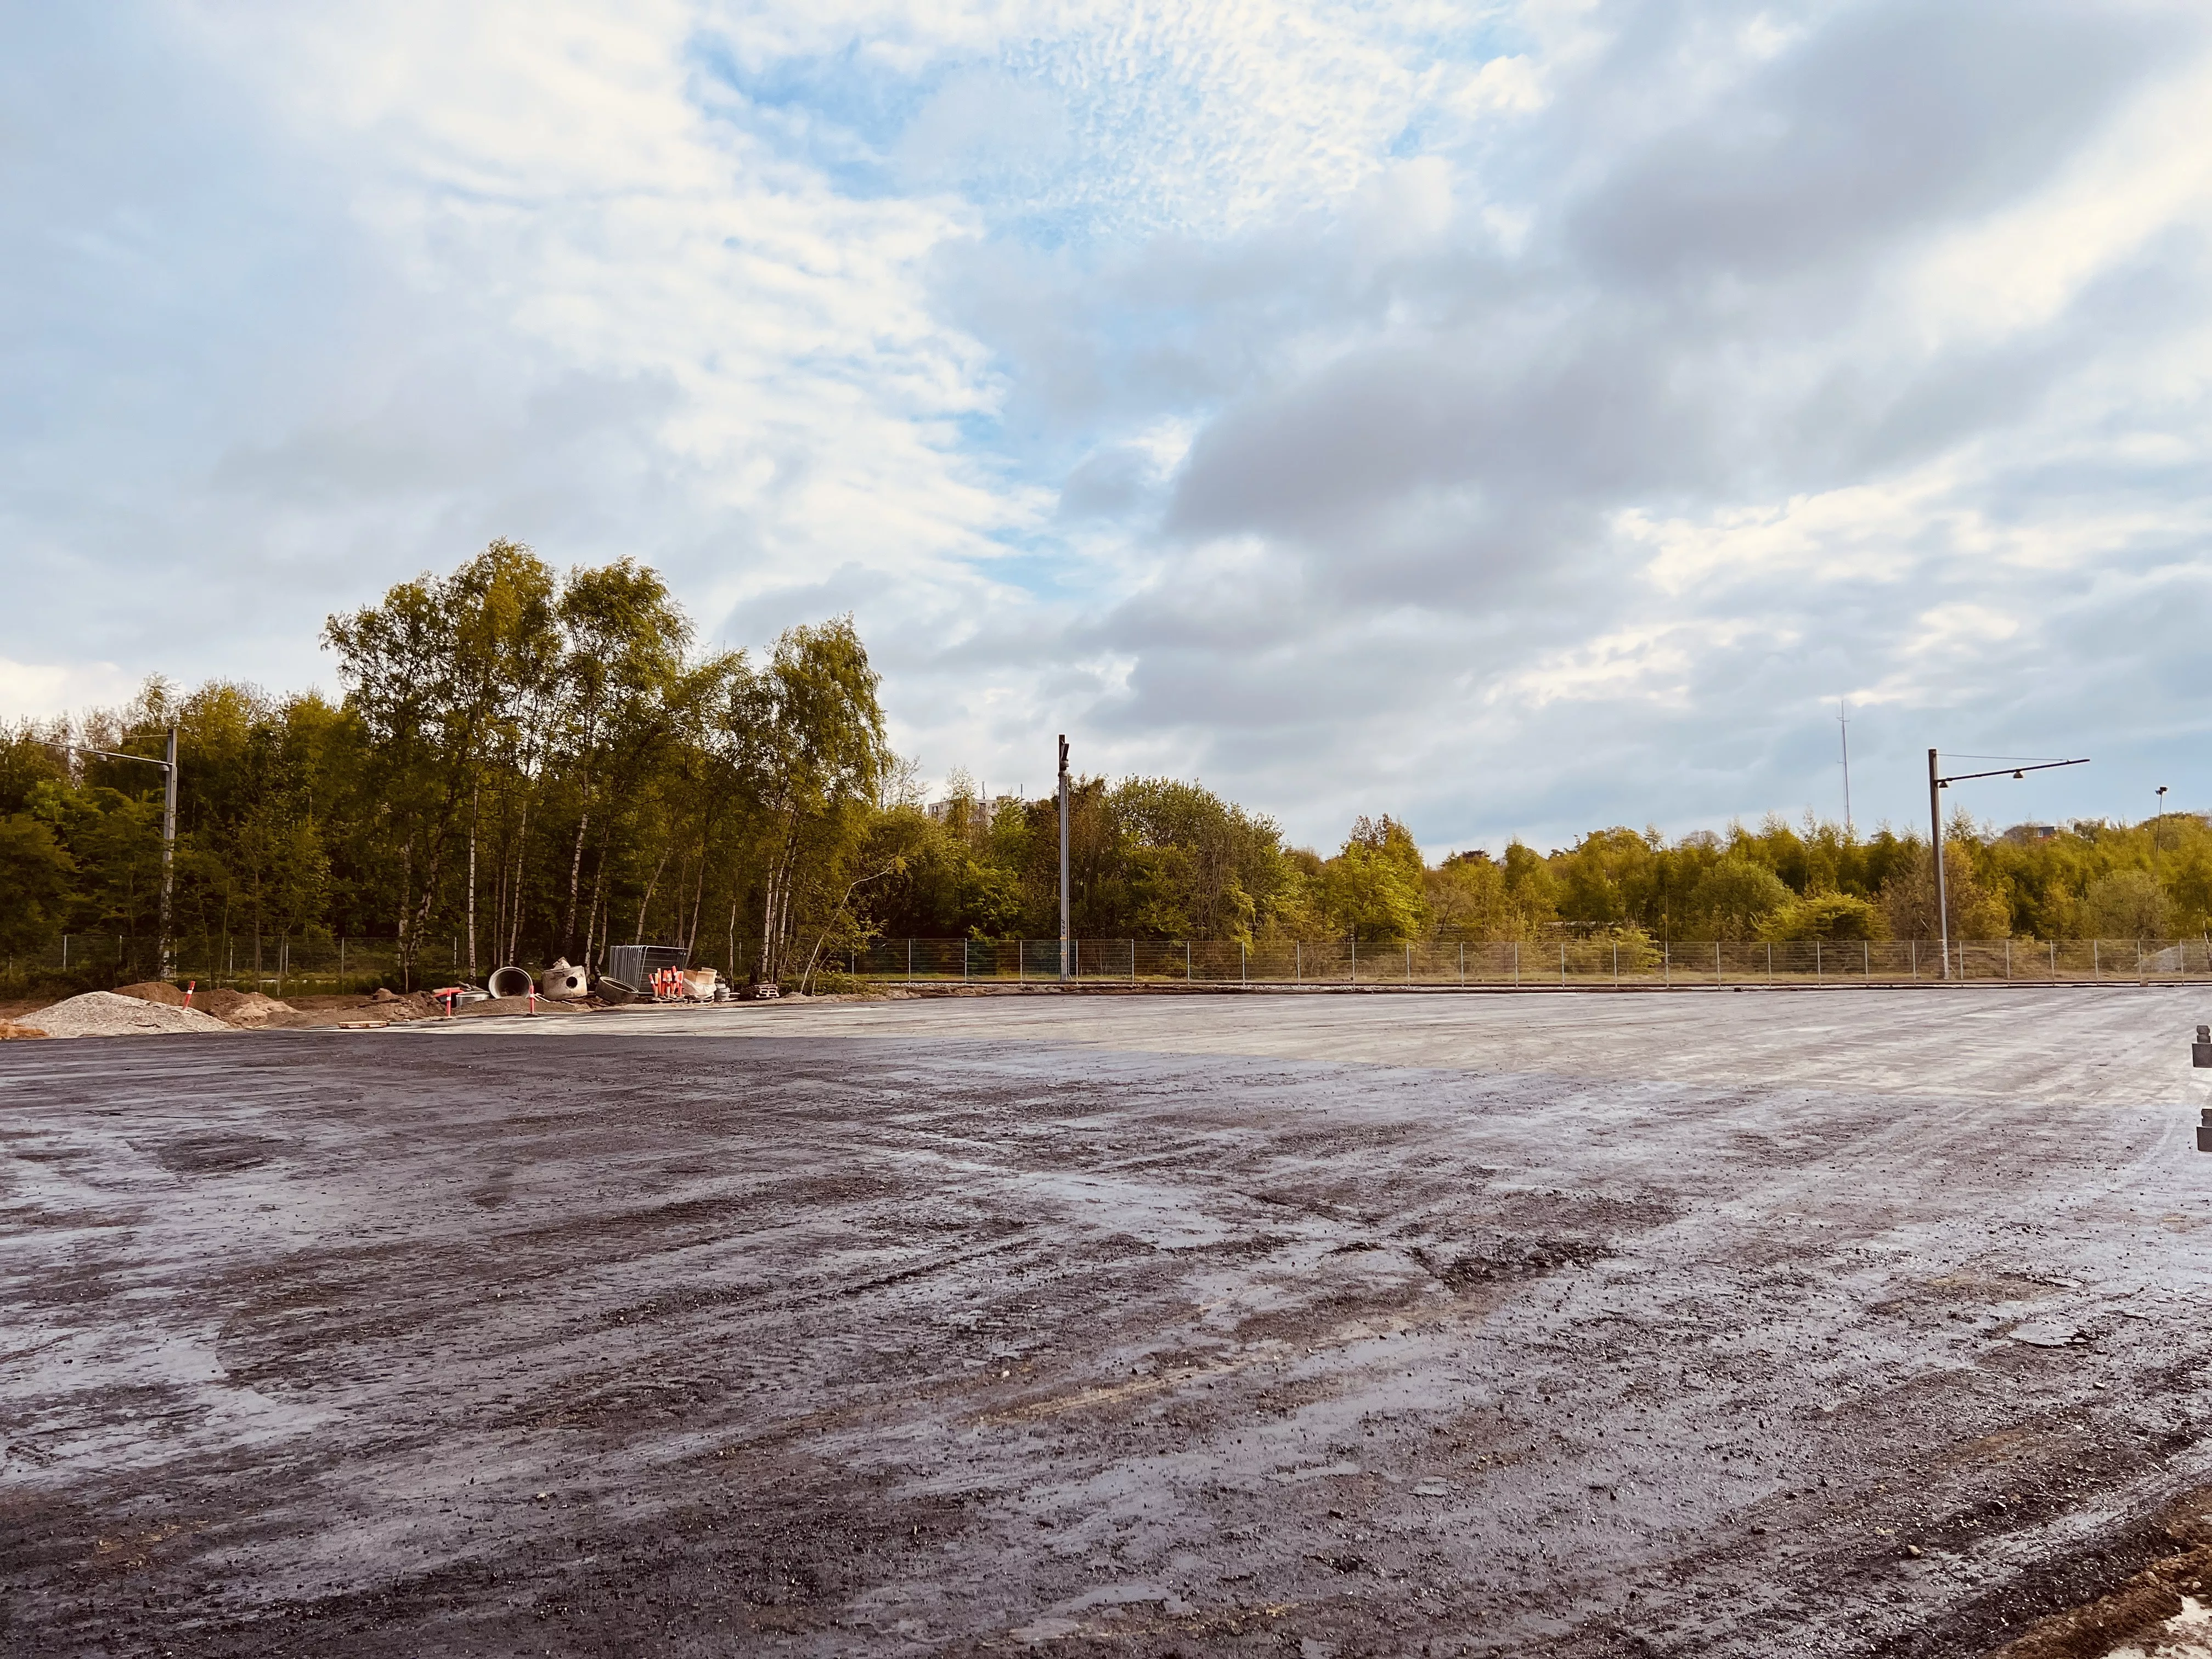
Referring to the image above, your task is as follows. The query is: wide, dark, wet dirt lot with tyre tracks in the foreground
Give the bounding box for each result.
[13,989,2212,1657]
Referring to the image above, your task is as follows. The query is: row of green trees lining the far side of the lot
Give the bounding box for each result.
[0,542,2212,980]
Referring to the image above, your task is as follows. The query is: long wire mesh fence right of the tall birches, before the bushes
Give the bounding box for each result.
[836,938,2212,989]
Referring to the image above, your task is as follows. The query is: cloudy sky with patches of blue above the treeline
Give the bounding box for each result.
[0,0,2212,851]
